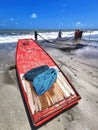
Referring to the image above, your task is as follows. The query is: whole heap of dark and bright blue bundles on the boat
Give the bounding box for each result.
[24,65,57,95]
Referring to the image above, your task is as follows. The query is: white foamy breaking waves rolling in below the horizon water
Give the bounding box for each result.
[0,31,98,43]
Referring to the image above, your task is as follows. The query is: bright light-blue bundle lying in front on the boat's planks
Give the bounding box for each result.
[32,68,57,95]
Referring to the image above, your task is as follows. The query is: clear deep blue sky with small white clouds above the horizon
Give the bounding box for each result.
[0,0,98,29]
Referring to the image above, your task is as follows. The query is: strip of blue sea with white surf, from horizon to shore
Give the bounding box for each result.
[0,29,98,43]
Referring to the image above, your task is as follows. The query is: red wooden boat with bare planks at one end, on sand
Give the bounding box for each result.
[16,39,80,126]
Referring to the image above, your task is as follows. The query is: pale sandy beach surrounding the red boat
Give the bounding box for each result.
[0,41,98,130]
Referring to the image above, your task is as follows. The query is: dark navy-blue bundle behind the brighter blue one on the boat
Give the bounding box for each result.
[24,65,49,81]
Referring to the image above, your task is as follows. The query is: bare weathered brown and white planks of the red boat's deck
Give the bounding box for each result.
[24,74,75,114]
